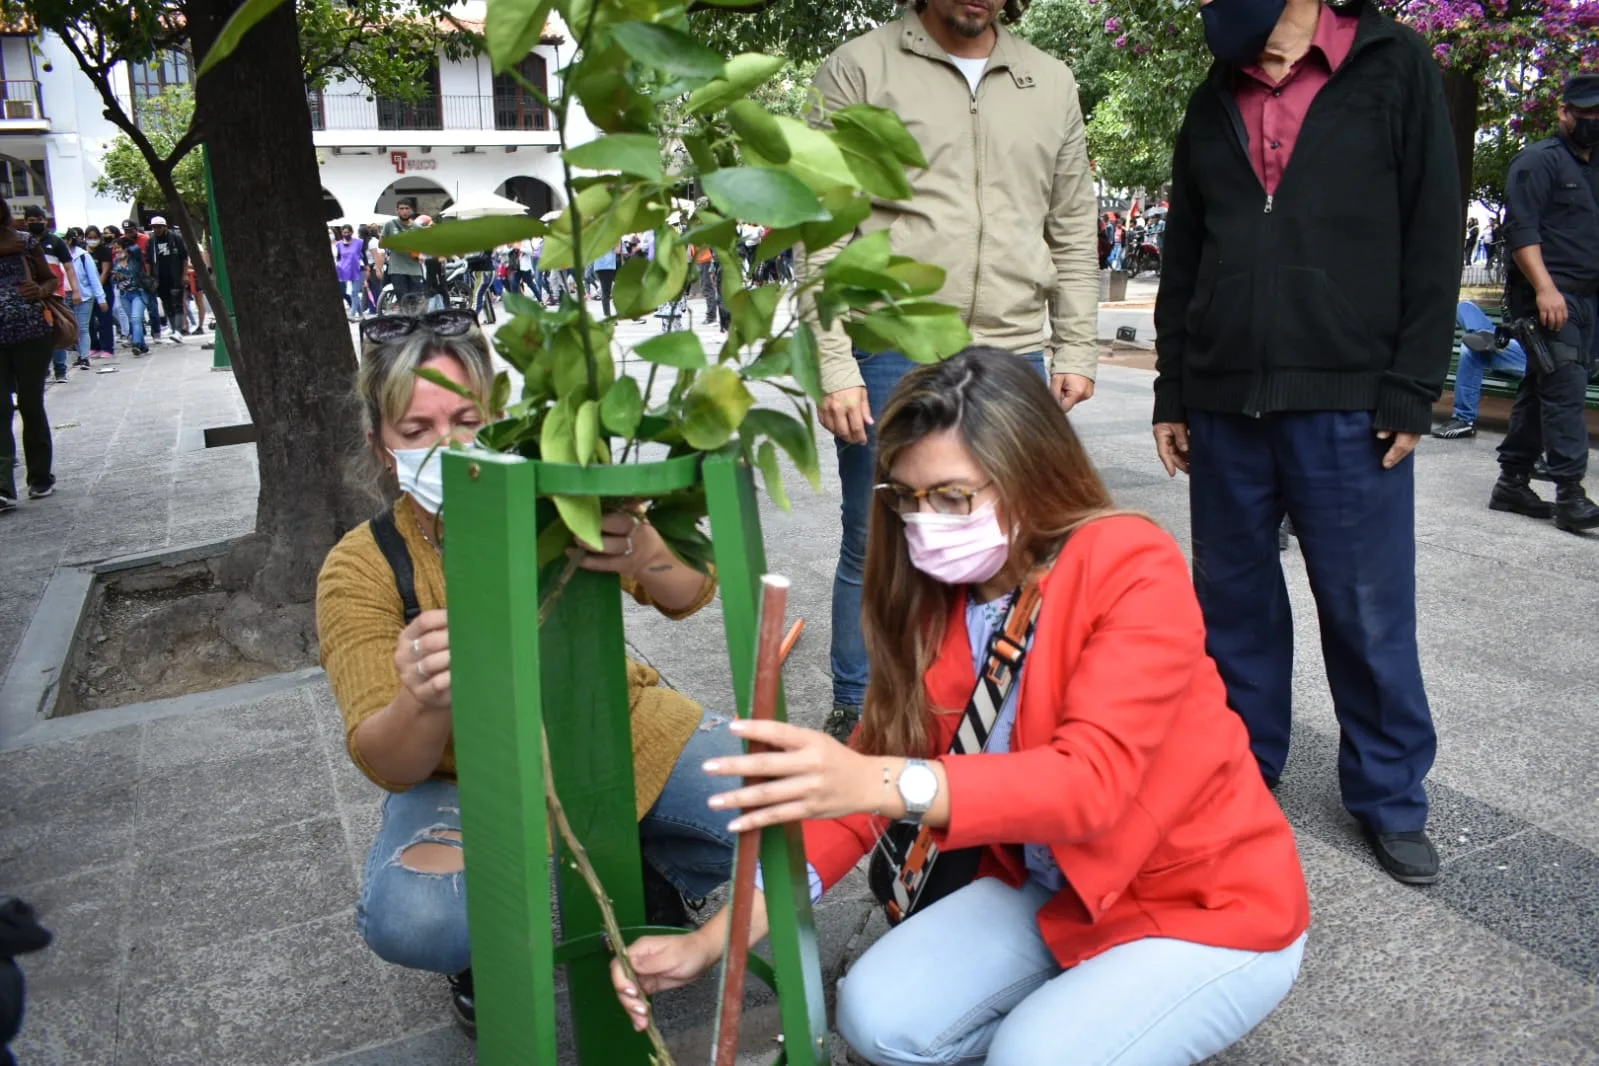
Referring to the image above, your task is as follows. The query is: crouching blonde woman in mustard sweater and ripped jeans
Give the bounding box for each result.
[317,310,740,1026]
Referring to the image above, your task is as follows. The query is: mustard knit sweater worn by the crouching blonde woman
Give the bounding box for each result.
[317,497,716,817]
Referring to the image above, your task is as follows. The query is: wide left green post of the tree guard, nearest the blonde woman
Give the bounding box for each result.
[445,452,559,1066]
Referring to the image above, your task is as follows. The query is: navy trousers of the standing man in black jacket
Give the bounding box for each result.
[1188,411,1438,833]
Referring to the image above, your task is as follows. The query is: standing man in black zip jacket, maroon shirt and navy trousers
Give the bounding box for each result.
[1154,0,1461,884]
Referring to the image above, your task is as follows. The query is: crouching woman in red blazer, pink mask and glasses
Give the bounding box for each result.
[614,348,1310,1066]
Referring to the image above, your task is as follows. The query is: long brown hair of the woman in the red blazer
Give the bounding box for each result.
[857,347,1113,756]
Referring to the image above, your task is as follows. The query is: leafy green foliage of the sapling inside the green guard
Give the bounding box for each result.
[362,0,971,563]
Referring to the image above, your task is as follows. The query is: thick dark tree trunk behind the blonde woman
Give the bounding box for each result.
[184,0,373,604]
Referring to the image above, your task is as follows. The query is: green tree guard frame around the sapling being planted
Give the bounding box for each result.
[445,452,828,1066]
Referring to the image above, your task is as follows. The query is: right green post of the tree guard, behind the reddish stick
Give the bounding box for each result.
[705,455,831,1066]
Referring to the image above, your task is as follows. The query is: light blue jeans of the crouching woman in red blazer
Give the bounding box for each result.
[838,877,1305,1066]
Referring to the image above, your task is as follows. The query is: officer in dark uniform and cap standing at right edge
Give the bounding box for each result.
[1489,74,1599,532]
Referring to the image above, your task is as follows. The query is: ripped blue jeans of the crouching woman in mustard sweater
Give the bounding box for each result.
[355,714,744,973]
